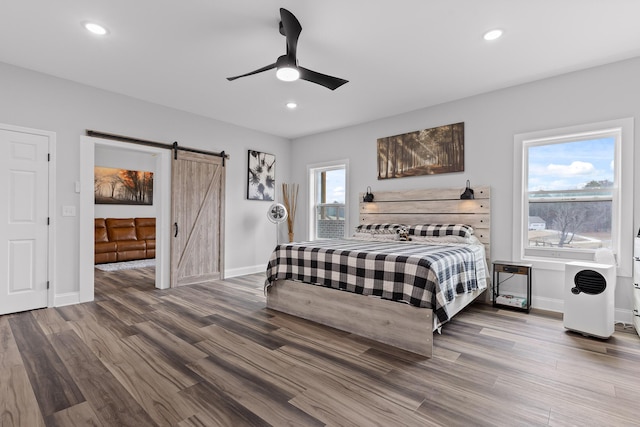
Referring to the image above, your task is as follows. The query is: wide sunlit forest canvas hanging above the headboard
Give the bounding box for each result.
[377,122,464,179]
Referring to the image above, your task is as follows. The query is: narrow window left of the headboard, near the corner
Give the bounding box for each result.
[309,161,347,240]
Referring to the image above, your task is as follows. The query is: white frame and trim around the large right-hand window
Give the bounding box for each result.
[512,118,634,277]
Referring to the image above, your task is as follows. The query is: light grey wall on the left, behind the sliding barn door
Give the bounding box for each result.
[0,59,291,300]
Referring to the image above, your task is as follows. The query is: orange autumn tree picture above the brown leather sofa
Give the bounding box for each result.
[93,166,153,205]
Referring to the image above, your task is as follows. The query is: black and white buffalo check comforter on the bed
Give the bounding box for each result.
[266,239,487,328]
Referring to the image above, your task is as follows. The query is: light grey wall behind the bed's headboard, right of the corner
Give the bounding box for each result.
[291,58,640,321]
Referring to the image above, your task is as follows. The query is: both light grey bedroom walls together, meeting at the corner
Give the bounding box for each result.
[0,58,640,318]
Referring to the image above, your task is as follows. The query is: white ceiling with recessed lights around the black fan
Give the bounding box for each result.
[0,0,640,139]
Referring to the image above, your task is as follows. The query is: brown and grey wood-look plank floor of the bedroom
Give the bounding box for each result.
[0,268,640,427]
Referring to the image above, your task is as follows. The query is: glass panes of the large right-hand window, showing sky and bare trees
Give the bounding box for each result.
[524,135,620,252]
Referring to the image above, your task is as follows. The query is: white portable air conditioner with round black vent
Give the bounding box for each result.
[563,254,616,338]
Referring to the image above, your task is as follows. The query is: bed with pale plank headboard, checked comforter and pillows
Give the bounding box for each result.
[266,187,490,357]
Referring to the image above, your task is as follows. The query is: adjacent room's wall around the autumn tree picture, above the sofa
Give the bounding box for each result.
[94,147,157,218]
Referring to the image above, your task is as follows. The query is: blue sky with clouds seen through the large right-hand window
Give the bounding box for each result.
[529,137,615,191]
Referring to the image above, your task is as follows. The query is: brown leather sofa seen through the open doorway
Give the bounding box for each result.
[95,218,156,264]
